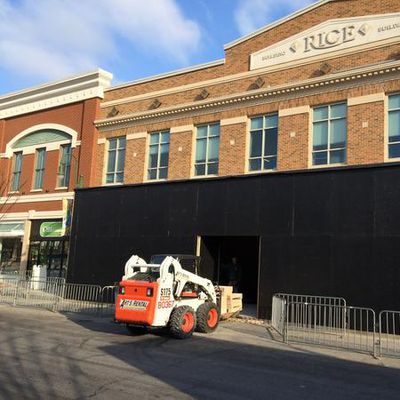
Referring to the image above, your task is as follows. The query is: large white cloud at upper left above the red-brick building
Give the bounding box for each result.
[0,0,201,79]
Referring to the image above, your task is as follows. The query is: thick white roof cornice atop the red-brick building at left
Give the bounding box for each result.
[0,69,112,119]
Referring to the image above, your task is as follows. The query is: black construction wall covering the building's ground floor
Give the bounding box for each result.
[68,165,400,317]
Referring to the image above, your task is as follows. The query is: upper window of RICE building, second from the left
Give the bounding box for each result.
[147,131,169,180]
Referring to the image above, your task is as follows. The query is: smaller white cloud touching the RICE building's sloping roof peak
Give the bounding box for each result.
[234,0,315,35]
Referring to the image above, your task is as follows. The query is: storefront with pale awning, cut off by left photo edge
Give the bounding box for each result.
[0,221,24,273]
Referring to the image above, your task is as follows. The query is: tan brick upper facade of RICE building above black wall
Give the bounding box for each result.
[96,0,400,185]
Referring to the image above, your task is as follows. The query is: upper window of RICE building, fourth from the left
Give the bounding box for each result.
[249,114,278,171]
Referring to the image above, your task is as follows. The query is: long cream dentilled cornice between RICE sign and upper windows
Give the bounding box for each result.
[95,61,400,128]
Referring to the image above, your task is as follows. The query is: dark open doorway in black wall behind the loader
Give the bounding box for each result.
[200,236,260,303]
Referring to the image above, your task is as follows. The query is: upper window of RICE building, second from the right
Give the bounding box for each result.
[312,103,347,165]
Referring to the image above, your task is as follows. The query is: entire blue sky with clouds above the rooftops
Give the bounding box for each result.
[0,0,313,94]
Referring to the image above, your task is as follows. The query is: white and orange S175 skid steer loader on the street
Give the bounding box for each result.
[115,255,220,339]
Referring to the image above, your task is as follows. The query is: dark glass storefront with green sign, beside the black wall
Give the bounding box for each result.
[28,219,69,277]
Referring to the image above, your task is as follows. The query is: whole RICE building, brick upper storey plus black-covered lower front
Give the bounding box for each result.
[4,0,400,316]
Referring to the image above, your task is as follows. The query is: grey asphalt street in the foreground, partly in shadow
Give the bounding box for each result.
[0,305,400,400]
